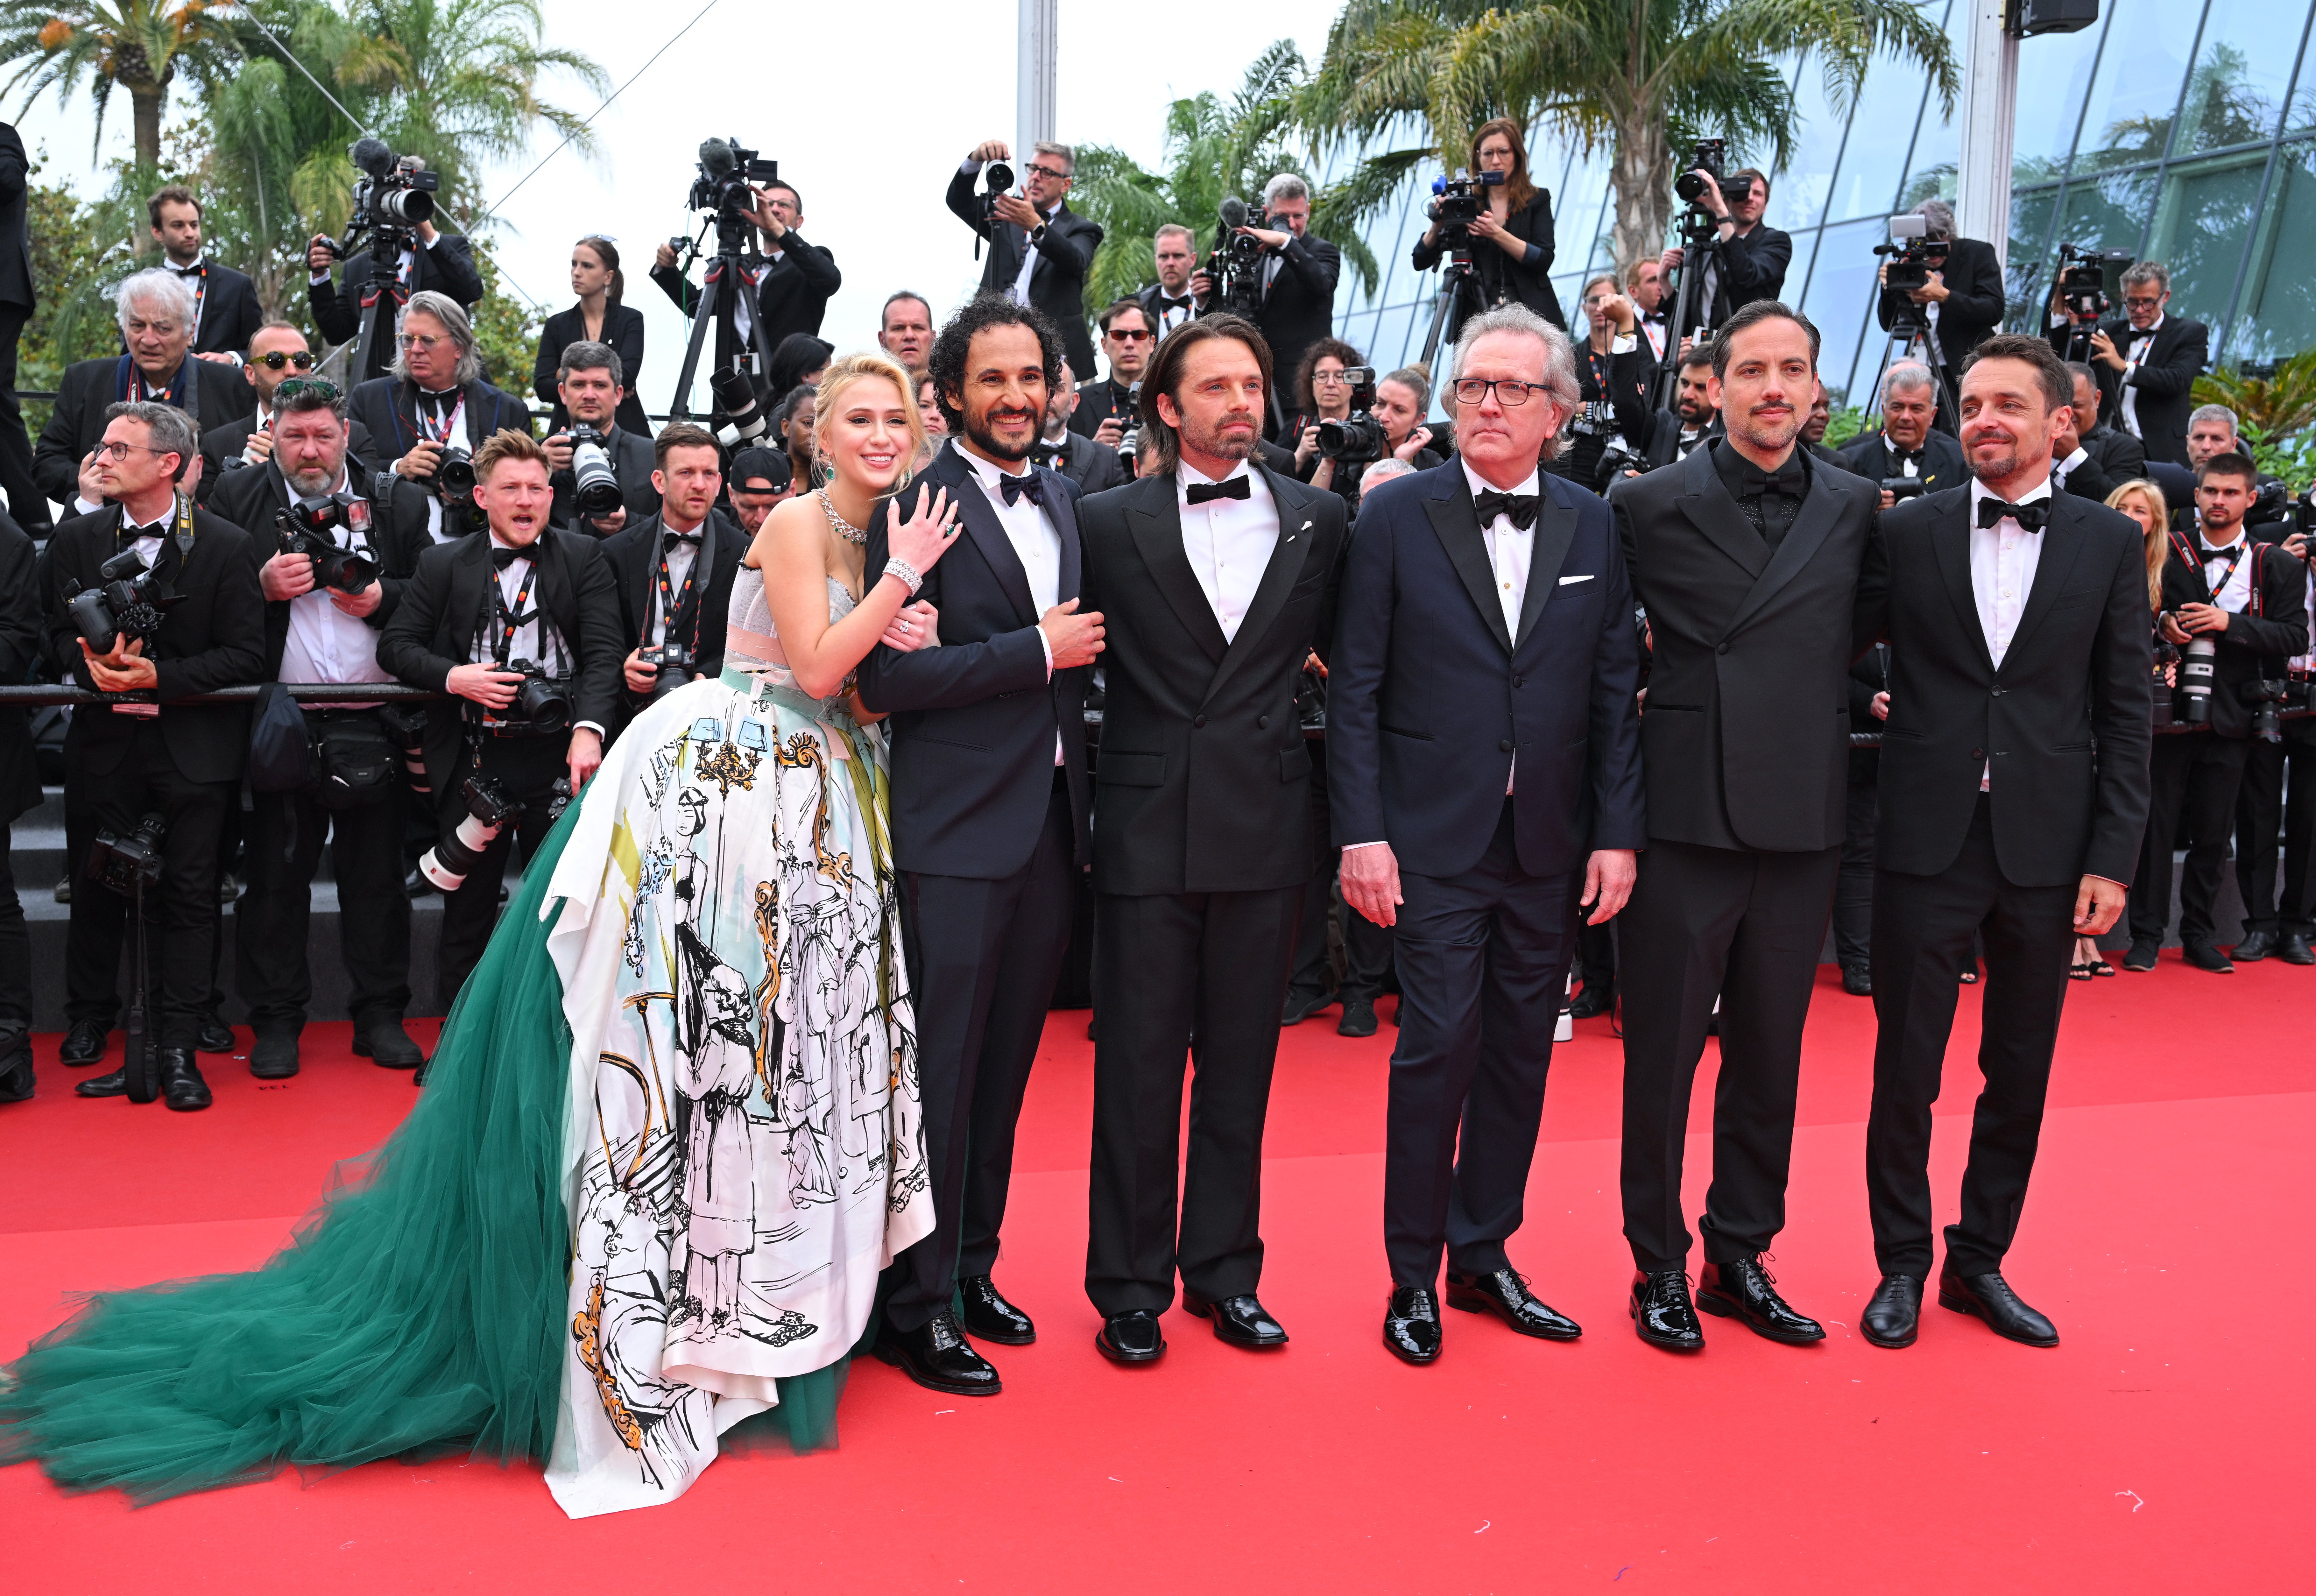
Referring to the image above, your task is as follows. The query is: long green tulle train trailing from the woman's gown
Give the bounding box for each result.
[0,806,845,1501]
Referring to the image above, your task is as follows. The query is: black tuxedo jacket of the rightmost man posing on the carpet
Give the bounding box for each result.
[1862,486,2149,887]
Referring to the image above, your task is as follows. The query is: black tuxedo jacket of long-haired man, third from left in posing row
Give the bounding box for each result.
[1079,466,1345,896]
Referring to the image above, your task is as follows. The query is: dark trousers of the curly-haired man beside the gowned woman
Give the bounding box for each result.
[885,769,1075,1330]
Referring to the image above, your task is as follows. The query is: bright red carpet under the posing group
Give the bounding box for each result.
[0,957,2316,1596]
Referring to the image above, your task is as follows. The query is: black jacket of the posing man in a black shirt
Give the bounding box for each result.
[1610,440,1881,852]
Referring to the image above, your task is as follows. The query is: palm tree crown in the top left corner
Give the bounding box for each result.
[0,0,234,169]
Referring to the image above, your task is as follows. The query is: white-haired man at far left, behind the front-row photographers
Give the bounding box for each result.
[32,266,248,514]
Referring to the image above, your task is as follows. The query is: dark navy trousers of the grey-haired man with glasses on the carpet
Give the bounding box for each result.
[1380,799,1584,1288]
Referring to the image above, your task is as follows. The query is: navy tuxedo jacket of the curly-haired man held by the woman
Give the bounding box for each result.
[859,442,1091,880]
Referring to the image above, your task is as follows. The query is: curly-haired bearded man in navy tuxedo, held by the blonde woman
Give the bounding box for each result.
[859,299,1102,1397]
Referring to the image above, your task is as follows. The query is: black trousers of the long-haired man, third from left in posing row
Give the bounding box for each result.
[1086,885,1304,1318]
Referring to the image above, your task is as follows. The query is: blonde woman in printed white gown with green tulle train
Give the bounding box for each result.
[0,357,954,1517]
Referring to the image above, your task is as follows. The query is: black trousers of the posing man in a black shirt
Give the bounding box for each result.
[1619,841,1841,1274]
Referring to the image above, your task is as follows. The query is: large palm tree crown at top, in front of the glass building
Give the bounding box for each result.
[1297,0,1962,271]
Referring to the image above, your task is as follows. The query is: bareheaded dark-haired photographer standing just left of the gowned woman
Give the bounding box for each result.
[602,421,741,737]
